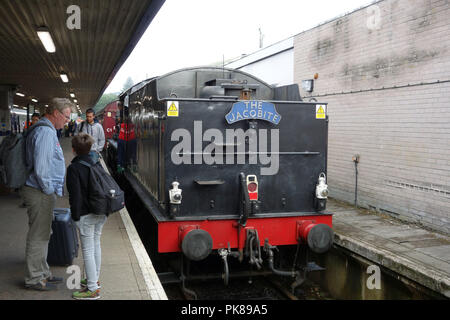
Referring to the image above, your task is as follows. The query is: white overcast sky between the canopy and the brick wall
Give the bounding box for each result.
[105,0,374,93]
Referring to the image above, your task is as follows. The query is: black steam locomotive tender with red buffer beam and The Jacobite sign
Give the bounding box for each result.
[110,67,333,292]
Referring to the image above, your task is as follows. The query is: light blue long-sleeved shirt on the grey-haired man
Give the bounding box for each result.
[25,117,66,197]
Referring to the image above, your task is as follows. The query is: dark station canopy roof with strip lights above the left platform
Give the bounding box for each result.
[0,0,164,112]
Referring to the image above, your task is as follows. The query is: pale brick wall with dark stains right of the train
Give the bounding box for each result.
[294,0,450,233]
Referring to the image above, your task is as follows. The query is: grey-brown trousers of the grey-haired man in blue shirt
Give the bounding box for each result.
[20,186,56,286]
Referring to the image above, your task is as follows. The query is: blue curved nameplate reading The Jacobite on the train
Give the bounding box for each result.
[225,101,281,124]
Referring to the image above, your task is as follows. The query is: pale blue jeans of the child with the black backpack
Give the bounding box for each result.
[75,214,106,291]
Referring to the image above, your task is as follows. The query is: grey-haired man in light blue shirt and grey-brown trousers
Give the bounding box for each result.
[21,98,72,291]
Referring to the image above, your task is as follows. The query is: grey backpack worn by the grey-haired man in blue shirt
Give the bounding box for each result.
[0,122,51,189]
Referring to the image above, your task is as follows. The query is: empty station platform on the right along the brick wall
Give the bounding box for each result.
[327,199,450,298]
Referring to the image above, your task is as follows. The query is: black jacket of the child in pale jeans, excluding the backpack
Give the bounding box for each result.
[66,155,94,221]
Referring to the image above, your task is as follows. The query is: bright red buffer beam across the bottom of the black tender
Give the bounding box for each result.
[158,214,332,253]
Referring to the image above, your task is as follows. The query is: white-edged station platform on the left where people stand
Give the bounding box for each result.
[0,138,167,300]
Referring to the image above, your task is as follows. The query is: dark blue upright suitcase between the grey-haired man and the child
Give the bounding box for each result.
[47,208,78,266]
